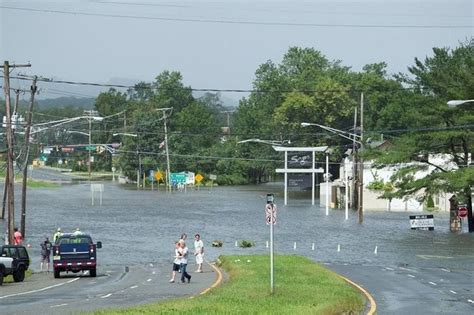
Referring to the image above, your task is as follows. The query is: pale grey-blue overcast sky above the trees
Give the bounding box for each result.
[0,0,474,99]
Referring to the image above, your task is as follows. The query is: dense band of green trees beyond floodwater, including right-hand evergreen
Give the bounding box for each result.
[5,39,474,227]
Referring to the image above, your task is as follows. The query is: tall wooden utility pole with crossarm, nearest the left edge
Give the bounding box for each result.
[1,61,31,244]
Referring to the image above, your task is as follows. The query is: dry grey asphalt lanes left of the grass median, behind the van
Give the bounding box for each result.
[0,264,216,314]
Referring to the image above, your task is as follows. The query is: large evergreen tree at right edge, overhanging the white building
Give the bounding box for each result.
[368,39,474,232]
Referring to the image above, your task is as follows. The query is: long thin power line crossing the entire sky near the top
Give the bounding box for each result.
[0,6,472,29]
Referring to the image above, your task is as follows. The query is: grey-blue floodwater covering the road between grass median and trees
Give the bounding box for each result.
[0,182,474,271]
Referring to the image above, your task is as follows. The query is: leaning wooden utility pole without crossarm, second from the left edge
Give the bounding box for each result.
[20,76,38,237]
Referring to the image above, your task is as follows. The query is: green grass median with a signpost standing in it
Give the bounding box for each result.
[94,255,365,315]
